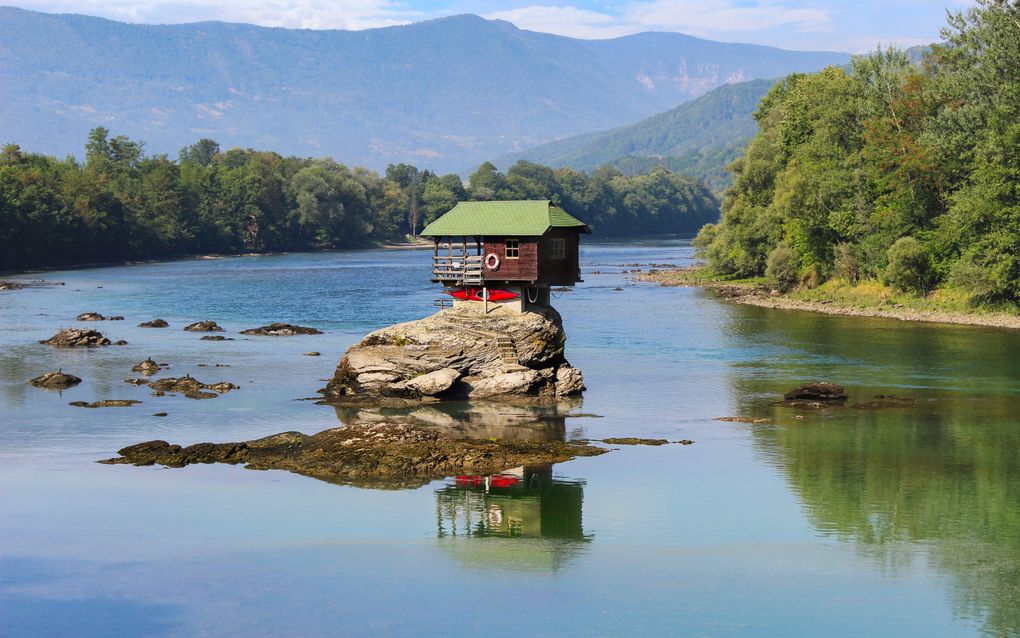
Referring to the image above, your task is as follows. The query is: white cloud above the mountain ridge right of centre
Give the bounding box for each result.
[486,0,832,38]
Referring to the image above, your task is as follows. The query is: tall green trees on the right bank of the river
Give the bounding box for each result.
[697,0,1020,304]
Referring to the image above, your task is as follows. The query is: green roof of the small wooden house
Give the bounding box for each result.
[421,199,589,237]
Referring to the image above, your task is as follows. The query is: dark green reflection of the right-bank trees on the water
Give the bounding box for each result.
[729,306,1020,636]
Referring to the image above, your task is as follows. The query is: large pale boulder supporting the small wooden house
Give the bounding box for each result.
[322,306,584,404]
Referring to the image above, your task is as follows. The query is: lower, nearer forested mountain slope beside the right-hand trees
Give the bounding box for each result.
[496,80,775,188]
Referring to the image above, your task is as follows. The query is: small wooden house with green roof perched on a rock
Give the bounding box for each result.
[421,200,591,312]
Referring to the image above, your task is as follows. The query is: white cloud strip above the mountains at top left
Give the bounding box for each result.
[7,0,414,29]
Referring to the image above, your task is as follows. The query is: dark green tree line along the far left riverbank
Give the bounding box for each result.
[0,128,718,271]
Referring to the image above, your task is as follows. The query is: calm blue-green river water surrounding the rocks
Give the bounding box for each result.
[0,241,1020,637]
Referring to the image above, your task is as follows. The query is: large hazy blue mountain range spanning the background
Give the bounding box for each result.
[0,7,848,170]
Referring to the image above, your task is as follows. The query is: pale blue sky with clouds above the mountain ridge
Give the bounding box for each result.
[7,0,973,53]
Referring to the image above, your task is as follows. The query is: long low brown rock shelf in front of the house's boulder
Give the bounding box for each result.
[101,424,605,487]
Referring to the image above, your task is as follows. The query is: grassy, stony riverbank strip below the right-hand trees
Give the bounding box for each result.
[632,267,1020,330]
